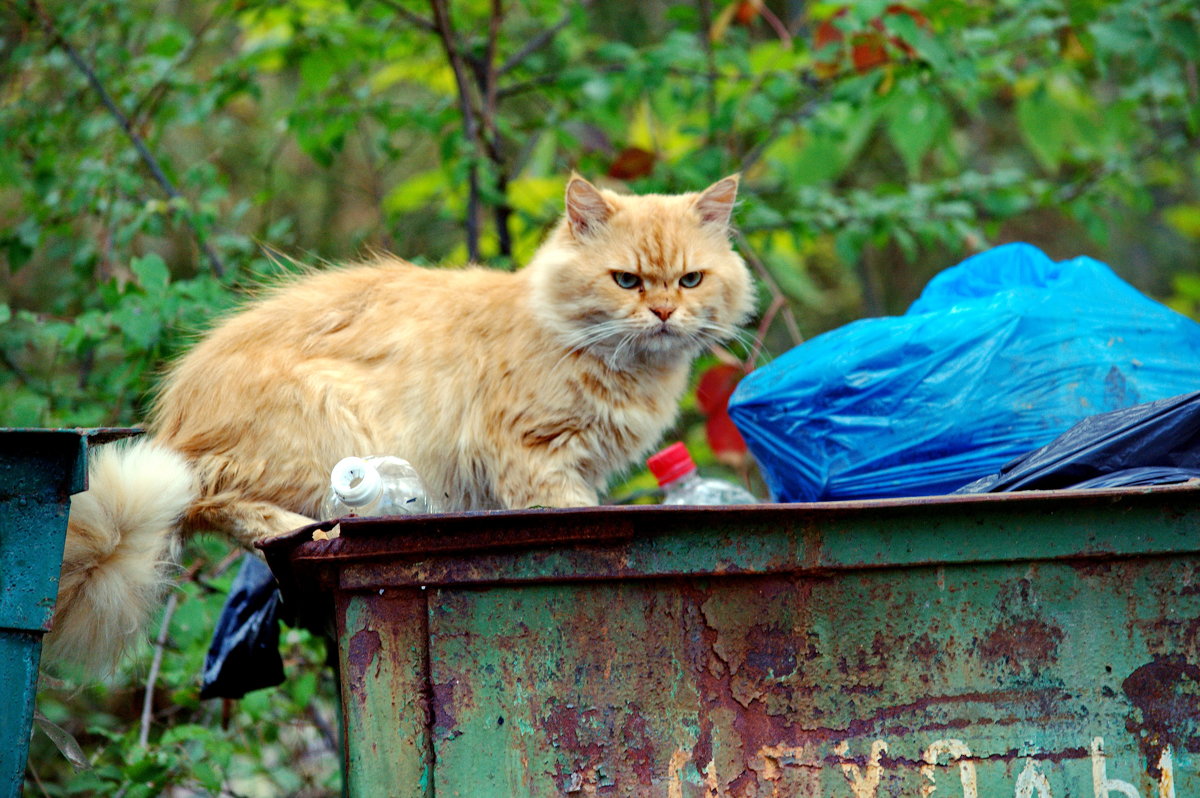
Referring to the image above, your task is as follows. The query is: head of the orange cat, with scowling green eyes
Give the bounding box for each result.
[527,175,754,368]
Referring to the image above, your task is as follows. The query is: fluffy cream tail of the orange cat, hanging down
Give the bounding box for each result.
[46,440,197,672]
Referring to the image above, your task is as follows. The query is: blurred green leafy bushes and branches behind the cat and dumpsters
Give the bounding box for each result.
[0,0,1200,797]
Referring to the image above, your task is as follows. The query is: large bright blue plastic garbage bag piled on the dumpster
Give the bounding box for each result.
[730,244,1200,502]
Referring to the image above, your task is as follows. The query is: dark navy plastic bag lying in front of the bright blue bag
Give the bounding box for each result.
[955,391,1200,493]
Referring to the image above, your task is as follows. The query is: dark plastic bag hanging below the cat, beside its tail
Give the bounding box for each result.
[200,554,283,698]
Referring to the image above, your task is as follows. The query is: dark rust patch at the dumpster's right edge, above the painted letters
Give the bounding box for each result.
[1121,654,1200,779]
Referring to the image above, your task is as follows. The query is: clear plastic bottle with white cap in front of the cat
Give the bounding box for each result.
[322,455,433,518]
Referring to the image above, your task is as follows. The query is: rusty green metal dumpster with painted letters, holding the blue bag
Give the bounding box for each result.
[264,485,1200,798]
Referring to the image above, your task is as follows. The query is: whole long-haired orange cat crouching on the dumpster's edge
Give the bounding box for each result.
[48,178,754,665]
